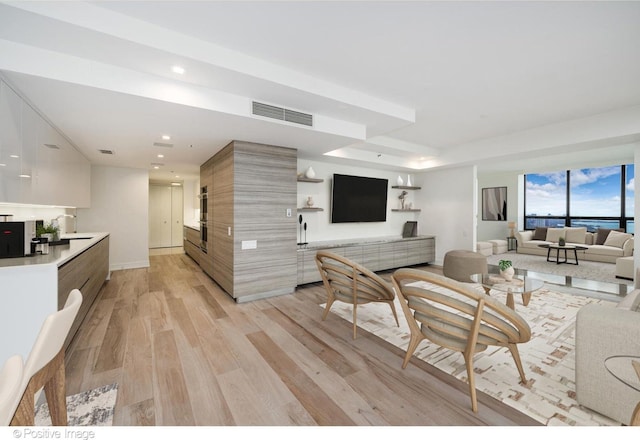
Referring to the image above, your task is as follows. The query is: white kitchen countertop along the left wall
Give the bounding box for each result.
[0,232,109,268]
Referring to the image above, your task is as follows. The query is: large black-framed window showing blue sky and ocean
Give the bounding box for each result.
[525,165,635,233]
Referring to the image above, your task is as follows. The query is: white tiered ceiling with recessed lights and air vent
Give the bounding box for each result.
[0,1,640,179]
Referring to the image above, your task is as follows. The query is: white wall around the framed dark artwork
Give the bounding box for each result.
[477,172,524,241]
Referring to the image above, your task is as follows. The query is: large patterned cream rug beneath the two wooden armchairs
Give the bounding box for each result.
[322,286,620,426]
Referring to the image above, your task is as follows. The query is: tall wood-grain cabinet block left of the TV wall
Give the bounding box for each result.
[200,141,297,302]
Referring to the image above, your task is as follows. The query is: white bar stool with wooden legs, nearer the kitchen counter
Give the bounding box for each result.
[11,289,82,426]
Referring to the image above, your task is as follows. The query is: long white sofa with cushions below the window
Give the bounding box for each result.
[516,227,634,263]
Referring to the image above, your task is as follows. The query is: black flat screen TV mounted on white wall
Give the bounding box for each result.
[331,174,389,223]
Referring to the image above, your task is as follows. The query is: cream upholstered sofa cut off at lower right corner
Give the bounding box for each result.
[575,282,640,425]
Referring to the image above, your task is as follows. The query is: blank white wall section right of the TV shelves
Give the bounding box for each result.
[416,163,478,265]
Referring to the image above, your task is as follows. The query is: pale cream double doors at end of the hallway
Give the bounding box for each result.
[149,183,184,249]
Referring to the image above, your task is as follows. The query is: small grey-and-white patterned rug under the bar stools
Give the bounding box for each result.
[35,383,118,426]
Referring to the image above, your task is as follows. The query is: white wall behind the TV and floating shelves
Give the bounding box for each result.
[296,159,426,242]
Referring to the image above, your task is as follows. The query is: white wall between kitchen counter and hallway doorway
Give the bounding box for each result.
[77,166,149,270]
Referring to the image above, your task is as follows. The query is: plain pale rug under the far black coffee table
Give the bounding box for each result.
[487,252,633,284]
